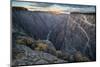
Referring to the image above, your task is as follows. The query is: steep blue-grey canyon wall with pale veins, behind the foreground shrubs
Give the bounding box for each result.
[12,7,96,60]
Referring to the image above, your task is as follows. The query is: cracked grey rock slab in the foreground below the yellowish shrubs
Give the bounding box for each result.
[12,44,67,66]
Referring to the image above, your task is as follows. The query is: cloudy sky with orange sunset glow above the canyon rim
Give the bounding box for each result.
[12,0,95,12]
